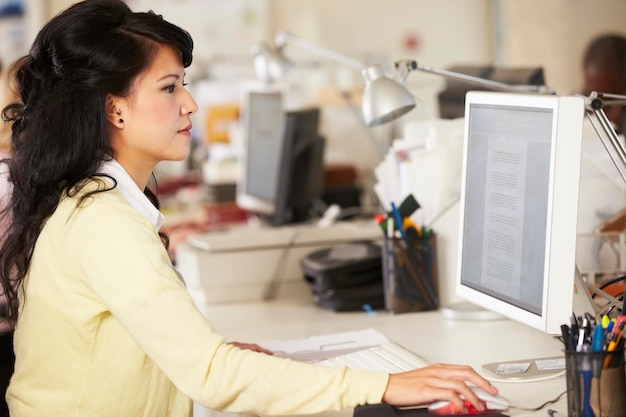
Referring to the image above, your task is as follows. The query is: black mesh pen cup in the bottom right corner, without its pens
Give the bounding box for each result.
[565,350,626,417]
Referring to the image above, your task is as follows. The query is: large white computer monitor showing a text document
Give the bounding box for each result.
[456,92,584,334]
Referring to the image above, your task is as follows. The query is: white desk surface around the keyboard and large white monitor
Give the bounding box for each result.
[196,290,567,417]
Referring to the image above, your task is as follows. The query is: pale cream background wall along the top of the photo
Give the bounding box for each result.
[18,0,626,93]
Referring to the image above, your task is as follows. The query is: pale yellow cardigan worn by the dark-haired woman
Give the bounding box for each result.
[7,183,389,417]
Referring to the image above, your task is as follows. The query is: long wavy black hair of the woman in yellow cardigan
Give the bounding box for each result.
[0,0,193,320]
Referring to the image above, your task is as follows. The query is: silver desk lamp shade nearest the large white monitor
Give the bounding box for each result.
[362,65,416,127]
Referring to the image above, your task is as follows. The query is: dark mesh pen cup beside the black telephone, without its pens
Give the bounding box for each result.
[382,233,439,314]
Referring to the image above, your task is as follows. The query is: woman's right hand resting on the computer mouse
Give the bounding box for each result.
[383,364,498,411]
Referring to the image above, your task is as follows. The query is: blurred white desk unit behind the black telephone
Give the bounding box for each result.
[176,221,382,305]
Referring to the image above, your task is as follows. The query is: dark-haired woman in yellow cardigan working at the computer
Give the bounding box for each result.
[0,0,496,417]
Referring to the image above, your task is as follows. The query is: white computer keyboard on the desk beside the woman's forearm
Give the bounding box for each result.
[317,342,430,374]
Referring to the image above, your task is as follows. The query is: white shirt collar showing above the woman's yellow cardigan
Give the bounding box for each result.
[100,159,163,230]
